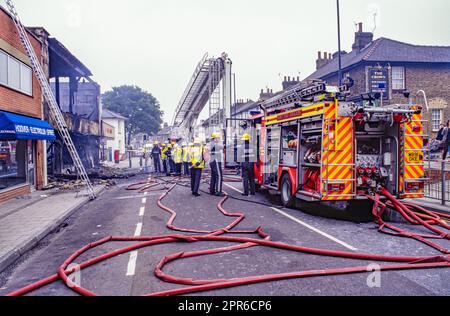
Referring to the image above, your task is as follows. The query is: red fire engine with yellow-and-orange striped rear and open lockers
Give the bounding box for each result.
[239,80,426,207]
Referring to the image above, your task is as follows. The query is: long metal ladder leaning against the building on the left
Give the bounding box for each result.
[5,0,96,200]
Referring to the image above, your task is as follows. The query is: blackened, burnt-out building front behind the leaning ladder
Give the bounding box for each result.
[29,28,103,176]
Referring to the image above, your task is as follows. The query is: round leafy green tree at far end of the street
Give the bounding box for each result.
[102,85,164,135]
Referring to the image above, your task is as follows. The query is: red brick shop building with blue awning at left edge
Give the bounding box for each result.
[0,7,55,202]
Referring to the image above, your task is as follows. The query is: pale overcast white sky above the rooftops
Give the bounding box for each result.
[8,0,450,122]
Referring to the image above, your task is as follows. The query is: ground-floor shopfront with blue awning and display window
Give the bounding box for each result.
[0,111,56,202]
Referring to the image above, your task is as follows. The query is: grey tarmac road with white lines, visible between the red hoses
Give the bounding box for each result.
[0,172,450,296]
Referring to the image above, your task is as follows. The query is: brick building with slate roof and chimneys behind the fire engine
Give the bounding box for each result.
[307,23,450,137]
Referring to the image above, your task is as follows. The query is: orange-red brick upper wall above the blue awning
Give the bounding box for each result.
[0,9,42,119]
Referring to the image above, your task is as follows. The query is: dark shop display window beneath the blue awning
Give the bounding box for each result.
[0,140,28,190]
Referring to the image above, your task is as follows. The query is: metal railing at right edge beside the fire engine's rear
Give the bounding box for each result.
[425,159,450,205]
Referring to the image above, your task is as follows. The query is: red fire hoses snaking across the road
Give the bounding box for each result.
[4,182,450,296]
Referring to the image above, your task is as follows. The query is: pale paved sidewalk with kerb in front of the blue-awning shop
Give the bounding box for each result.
[0,186,105,272]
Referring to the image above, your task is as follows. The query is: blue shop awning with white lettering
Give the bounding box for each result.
[0,111,56,140]
